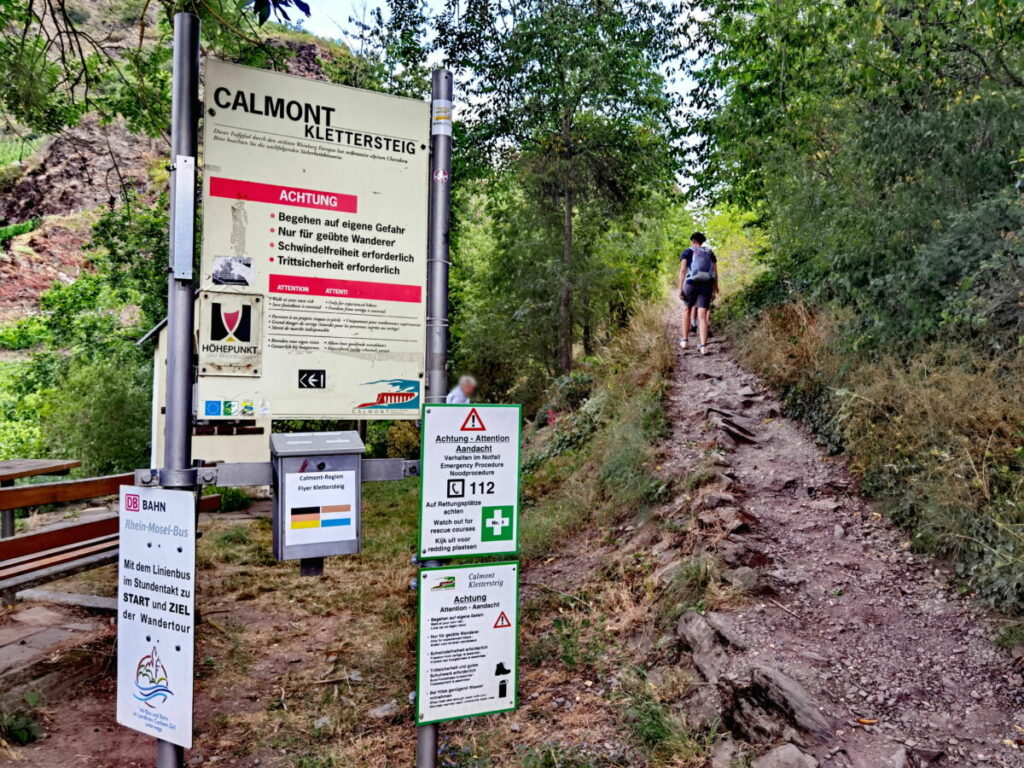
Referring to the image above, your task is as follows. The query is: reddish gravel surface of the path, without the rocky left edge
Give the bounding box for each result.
[666,309,1024,768]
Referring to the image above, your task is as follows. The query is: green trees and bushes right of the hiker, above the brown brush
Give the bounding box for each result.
[691,0,1024,347]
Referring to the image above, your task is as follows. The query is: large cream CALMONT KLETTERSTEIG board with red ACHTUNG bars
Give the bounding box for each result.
[197,59,430,420]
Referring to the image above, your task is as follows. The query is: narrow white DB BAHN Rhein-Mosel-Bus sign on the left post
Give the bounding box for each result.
[118,485,196,749]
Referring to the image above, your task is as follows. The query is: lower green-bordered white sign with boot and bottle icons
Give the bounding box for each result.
[416,562,519,725]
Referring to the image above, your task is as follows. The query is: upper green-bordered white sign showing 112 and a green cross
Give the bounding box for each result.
[420,406,522,558]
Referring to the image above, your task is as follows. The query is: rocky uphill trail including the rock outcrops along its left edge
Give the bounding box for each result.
[530,303,1024,768]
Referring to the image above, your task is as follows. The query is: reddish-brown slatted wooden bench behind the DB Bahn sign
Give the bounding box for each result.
[0,474,220,602]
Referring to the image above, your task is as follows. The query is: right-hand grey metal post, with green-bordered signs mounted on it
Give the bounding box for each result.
[416,70,454,768]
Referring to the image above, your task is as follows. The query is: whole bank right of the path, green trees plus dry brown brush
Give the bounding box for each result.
[690,0,1024,609]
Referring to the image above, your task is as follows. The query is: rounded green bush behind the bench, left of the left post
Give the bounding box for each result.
[40,348,152,475]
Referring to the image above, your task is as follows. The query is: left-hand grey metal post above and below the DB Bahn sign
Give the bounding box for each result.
[157,13,200,768]
